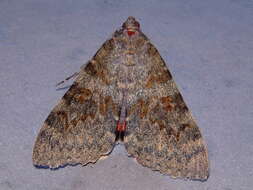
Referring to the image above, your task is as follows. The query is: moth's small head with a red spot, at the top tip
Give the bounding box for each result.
[122,16,140,36]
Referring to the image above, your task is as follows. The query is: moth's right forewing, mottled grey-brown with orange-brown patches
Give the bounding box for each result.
[125,42,209,180]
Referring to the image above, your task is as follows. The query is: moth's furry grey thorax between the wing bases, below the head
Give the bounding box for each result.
[111,36,150,100]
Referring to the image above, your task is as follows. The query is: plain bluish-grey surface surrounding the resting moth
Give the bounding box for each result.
[0,0,253,190]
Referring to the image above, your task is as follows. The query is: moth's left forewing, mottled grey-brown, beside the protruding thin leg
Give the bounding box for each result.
[33,40,117,168]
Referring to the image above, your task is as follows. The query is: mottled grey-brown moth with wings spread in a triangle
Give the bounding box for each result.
[33,17,209,180]
